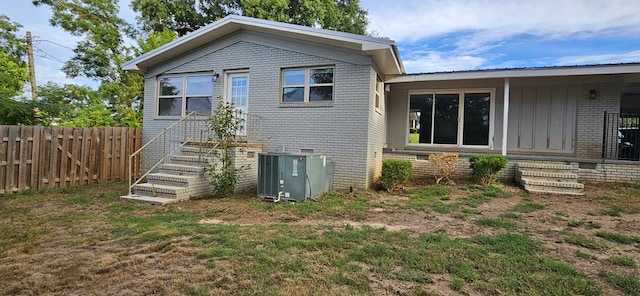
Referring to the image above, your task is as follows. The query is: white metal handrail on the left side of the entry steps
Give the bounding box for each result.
[128,111,198,195]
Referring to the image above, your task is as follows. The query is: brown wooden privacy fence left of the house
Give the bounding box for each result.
[0,126,142,193]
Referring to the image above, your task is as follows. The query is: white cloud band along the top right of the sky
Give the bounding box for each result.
[362,0,640,44]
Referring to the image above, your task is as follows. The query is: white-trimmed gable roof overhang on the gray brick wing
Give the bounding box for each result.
[122,15,404,75]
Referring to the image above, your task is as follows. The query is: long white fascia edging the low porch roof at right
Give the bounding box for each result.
[386,63,640,83]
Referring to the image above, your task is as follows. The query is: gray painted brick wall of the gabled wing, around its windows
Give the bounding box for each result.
[143,34,381,188]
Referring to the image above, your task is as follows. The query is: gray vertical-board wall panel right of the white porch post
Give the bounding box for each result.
[507,86,577,153]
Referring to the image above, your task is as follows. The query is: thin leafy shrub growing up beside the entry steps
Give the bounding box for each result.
[206,100,249,196]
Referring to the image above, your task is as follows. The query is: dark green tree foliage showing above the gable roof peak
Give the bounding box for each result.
[131,0,367,34]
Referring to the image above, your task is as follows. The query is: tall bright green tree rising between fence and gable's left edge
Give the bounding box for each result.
[33,0,143,126]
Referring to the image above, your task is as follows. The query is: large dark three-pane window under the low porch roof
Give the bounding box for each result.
[408,91,493,146]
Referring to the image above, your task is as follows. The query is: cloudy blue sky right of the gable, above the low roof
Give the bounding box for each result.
[361,0,640,73]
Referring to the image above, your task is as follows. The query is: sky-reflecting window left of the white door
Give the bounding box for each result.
[158,75,213,116]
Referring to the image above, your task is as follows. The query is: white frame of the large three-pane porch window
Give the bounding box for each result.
[404,88,496,150]
